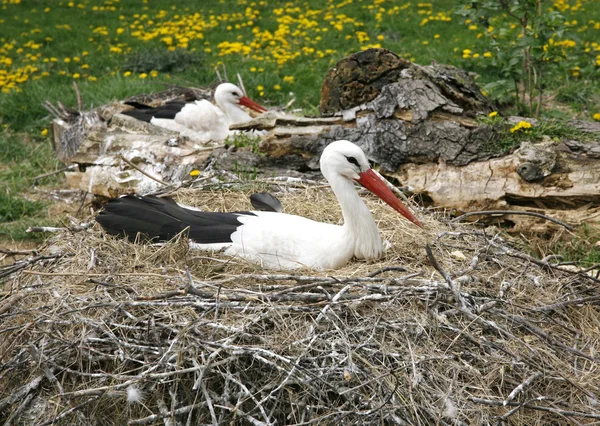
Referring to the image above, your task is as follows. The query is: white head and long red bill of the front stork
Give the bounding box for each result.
[320,140,423,226]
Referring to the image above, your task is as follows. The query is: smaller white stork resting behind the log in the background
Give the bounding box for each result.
[123,83,266,142]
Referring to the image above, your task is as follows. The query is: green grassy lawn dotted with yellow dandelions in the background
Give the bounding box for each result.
[0,0,600,260]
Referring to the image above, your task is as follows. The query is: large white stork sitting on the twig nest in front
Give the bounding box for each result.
[96,140,422,269]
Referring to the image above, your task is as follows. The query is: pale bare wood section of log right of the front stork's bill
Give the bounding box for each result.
[390,140,600,233]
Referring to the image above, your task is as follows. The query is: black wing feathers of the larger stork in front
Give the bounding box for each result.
[96,195,254,244]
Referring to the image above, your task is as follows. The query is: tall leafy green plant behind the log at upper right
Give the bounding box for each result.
[457,0,574,118]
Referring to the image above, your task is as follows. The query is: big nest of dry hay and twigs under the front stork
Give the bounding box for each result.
[0,184,600,425]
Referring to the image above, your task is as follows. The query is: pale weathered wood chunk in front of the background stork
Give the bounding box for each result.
[65,114,212,197]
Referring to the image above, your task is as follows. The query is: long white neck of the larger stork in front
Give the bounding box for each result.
[326,174,383,259]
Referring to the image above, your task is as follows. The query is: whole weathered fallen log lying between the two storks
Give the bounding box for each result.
[54,49,600,232]
